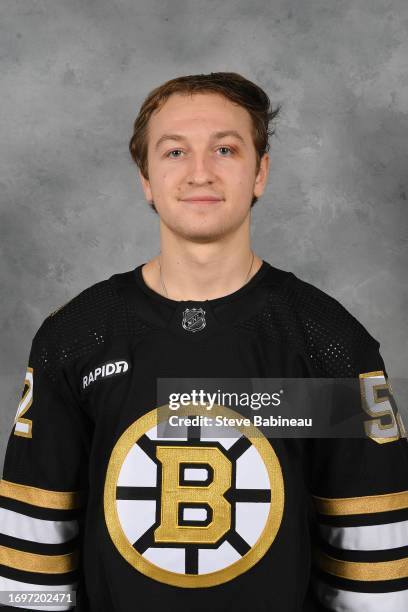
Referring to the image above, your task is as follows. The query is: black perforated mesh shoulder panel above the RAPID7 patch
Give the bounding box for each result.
[33,273,156,381]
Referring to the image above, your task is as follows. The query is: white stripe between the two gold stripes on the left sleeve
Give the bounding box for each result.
[0,508,78,544]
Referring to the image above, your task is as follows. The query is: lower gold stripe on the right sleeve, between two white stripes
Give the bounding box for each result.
[315,551,408,581]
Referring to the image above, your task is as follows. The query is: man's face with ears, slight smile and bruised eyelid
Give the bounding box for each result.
[139,93,269,242]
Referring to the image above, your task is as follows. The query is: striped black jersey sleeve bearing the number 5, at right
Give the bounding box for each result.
[310,336,408,612]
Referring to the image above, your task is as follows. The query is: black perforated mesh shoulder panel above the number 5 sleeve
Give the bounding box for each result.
[239,274,379,378]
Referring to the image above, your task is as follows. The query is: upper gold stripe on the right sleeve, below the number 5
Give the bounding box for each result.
[313,491,408,516]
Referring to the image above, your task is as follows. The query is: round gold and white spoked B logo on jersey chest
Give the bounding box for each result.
[104,405,284,588]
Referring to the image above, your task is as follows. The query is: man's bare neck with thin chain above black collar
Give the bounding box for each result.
[142,241,262,301]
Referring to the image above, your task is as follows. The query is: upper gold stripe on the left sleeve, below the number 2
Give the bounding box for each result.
[0,479,82,510]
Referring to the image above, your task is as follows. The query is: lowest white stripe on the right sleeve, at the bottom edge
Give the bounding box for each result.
[314,580,408,612]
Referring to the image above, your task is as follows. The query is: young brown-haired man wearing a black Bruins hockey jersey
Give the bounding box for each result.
[0,73,408,612]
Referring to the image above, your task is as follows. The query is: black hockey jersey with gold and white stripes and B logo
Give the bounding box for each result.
[0,261,408,612]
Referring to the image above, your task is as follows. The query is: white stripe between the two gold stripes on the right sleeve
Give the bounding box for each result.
[319,521,408,550]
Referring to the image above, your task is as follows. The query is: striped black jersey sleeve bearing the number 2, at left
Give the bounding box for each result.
[0,318,90,610]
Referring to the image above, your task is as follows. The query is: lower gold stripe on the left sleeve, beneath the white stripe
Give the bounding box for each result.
[0,545,78,574]
